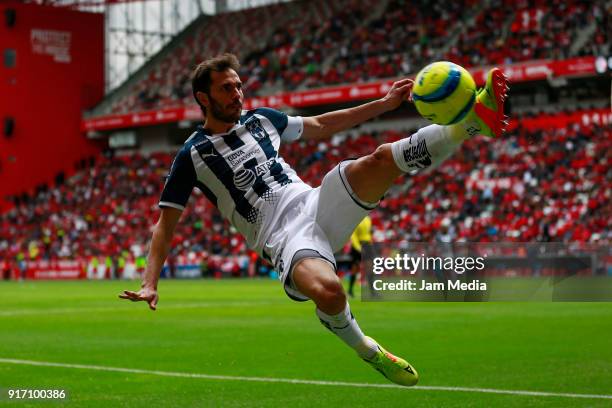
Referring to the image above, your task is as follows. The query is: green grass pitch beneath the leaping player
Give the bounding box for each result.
[0,280,612,408]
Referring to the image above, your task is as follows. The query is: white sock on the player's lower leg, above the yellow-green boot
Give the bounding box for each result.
[317,302,378,359]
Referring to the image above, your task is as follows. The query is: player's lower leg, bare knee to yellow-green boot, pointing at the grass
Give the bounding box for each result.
[290,258,419,386]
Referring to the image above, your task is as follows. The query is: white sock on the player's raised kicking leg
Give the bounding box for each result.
[391,125,468,173]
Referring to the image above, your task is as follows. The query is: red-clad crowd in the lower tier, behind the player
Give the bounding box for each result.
[0,120,612,275]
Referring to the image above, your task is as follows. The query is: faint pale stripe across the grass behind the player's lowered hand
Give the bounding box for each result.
[0,299,280,317]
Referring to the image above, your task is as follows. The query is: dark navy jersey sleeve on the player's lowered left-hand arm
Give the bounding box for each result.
[159,147,197,211]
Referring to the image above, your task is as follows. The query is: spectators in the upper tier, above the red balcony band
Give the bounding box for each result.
[107,0,612,113]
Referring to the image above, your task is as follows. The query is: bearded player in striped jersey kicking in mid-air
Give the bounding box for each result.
[120,54,507,385]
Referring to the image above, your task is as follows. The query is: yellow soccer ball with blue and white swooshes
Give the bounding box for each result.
[412,61,476,125]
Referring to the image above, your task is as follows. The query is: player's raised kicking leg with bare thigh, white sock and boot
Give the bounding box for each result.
[344,68,508,203]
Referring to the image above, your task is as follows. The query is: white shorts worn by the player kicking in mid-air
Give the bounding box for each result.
[264,160,378,301]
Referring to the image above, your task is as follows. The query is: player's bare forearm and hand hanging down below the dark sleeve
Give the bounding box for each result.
[119,208,182,310]
